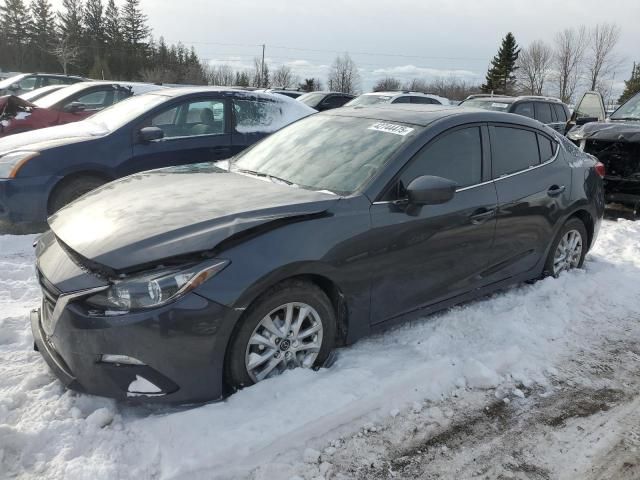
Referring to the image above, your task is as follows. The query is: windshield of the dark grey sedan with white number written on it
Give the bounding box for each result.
[230,115,419,195]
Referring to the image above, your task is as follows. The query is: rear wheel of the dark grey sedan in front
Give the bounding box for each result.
[544,218,588,277]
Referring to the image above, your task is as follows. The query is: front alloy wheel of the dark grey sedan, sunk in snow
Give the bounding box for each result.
[245,302,323,383]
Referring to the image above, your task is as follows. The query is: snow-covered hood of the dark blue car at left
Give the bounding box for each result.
[0,120,109,156]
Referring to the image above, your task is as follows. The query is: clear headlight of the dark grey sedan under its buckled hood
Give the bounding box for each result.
[85,259,229,315]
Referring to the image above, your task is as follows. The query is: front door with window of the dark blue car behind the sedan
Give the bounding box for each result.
[124,95,231,173]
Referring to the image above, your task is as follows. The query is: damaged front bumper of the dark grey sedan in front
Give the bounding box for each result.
[31,293,242,403]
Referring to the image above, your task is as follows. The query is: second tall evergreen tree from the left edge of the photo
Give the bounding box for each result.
[29,0,56,71]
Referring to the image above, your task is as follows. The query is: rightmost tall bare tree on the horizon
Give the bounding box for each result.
[585,23,620,90]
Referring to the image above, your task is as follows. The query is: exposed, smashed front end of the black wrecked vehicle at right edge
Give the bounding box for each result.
[584,140,640,182]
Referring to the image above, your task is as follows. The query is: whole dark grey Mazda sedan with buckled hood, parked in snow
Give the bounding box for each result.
[27,101,604,402]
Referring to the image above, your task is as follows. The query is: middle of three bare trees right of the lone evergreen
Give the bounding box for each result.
[554,25,587,103]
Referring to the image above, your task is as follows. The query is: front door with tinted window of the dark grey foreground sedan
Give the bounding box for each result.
[371,125,497,324]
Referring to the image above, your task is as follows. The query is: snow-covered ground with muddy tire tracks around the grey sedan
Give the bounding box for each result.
[0,220,640,480]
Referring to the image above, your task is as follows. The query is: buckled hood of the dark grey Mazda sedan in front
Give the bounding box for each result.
[49,164,340,270]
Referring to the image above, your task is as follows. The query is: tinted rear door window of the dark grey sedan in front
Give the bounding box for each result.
[491,127,540,178]
